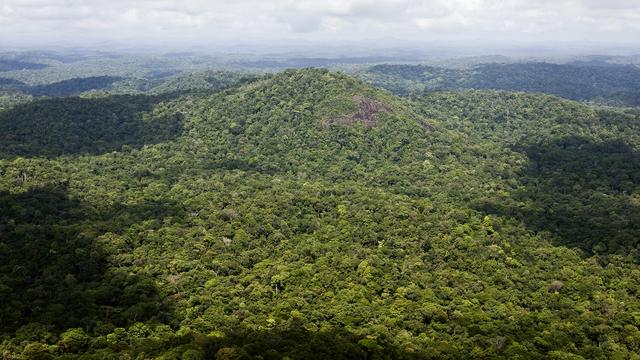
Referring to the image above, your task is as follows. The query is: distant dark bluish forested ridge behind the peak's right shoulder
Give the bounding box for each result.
[362,62,640,106]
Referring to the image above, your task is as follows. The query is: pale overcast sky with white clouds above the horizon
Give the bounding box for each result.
[0,0,640,50]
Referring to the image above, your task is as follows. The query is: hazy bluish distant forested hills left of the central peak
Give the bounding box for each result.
[0,52,245,109]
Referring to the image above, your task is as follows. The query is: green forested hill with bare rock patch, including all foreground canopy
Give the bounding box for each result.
[0,69,640,359]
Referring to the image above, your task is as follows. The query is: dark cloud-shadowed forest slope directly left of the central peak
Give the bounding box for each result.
[0,96,181,157]
